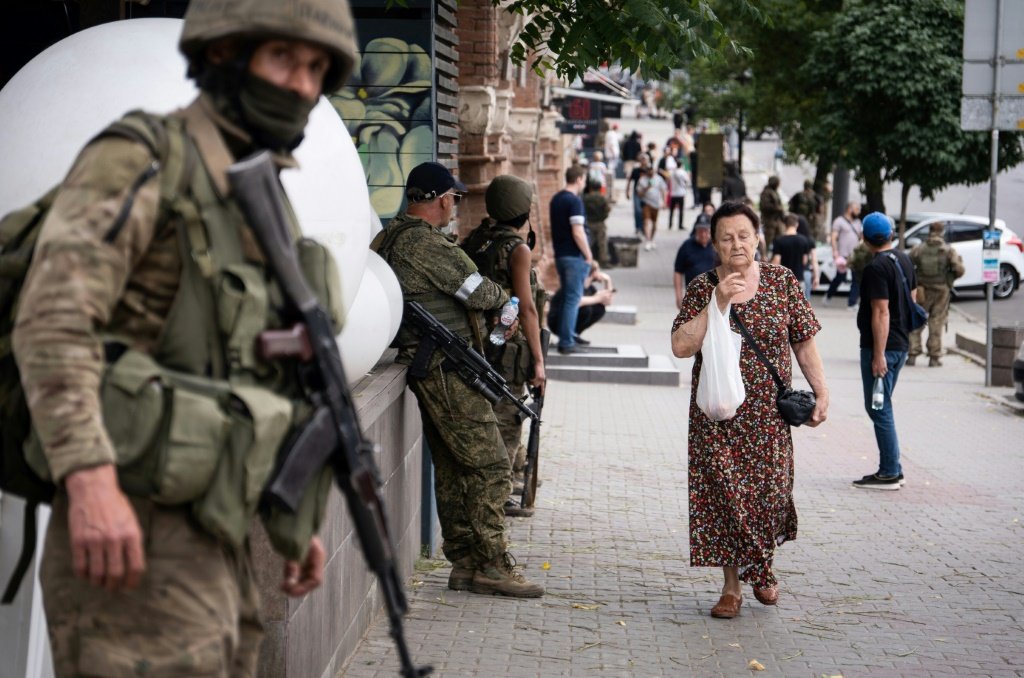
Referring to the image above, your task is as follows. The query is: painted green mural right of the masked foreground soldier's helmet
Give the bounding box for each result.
[330,3,436,222]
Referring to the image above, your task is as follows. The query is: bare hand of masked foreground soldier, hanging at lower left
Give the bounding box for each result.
[65,464,145,591]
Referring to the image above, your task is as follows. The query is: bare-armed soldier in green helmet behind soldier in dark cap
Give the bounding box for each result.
[462,174,546,517]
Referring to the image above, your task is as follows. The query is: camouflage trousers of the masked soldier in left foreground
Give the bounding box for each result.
[40,495,263,677]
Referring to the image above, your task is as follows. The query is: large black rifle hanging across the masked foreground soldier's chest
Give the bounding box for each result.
[227,152,432,678]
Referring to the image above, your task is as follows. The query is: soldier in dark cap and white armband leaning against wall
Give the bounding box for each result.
[371,162,544,598]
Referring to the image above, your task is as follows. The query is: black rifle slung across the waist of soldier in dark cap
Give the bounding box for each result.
[402,301,540,421]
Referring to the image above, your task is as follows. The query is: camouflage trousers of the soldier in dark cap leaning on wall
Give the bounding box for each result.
[409,367,512,562]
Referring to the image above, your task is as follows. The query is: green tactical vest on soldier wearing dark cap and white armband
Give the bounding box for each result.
[370,214,483,348]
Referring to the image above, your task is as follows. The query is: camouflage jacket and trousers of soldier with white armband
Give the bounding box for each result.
[371,214,512,563]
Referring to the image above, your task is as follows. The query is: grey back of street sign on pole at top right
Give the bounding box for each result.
[961,0,1024,131]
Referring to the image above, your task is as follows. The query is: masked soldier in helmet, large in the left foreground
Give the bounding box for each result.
[13,0,355,676]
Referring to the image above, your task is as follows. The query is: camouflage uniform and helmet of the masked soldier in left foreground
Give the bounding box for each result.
[13,0,355,676]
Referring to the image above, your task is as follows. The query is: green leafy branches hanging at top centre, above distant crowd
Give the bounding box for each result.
[494,0,763,81]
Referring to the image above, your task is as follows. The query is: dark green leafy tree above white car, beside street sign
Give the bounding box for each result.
[800,0,1024,239]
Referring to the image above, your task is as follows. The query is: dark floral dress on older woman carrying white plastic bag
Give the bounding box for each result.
[672,263,821,588]
